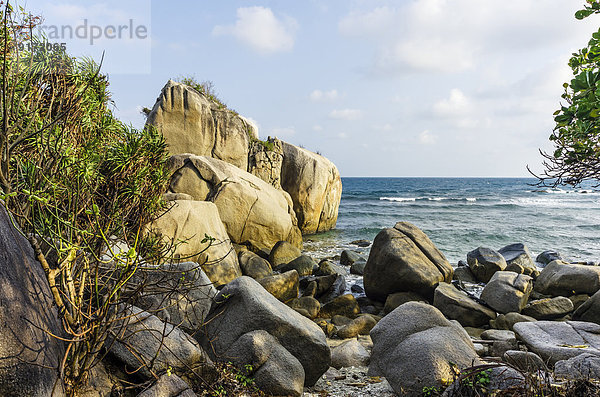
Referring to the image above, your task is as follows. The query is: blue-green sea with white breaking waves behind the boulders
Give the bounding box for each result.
[304,178,600,266]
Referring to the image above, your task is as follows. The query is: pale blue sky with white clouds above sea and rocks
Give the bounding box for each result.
[20,0,600,177]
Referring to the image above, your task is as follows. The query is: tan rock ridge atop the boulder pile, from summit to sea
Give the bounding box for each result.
[147,80,342,234]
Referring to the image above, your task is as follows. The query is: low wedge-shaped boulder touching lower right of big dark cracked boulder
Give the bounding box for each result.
[433,283,496,327]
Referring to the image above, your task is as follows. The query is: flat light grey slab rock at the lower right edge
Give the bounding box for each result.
[513,321,600,365]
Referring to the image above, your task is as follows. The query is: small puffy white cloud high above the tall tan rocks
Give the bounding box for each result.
[212,7,298,54]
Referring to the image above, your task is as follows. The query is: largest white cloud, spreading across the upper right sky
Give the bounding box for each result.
[338,0,590,75]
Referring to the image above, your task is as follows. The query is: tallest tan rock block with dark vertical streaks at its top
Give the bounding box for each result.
[147,80,256,171]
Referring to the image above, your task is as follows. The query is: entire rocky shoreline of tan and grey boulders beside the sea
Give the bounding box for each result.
[0,81,600,397]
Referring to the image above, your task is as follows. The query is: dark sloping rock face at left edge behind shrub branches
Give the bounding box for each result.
[0,202,64,397]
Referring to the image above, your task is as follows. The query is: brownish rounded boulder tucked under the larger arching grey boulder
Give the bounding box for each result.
[224,330,304,397]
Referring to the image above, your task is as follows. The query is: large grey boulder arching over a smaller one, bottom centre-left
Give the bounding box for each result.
[206,276,331,386]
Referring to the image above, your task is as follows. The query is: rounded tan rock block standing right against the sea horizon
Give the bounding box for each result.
[281,142,342,234]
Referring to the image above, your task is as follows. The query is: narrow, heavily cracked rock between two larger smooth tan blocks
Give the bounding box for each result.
[248,137,283,189]
